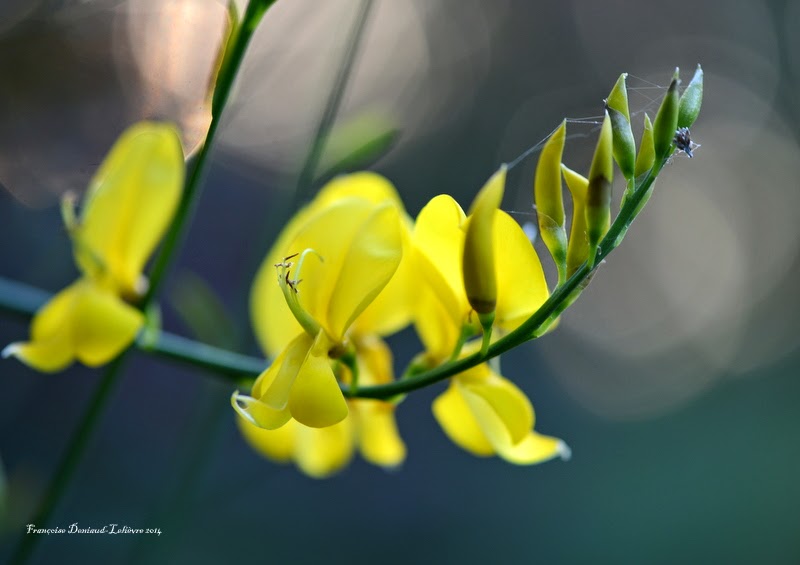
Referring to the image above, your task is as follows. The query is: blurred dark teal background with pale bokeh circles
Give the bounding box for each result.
[0,0,800,563]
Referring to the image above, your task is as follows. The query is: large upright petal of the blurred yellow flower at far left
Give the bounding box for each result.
[76,122,184,296]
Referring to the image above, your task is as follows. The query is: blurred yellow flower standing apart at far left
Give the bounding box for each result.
[3,122,184,372]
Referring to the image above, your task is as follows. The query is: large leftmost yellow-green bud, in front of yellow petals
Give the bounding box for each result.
[462,165,506,315]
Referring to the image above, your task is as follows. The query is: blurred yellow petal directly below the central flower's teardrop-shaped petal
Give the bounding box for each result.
[294,418,353,479]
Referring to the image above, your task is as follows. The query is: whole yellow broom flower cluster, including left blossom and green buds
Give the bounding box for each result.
[4,67,703,478]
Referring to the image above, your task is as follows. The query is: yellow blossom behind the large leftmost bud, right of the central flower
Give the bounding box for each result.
[413,188,568,464]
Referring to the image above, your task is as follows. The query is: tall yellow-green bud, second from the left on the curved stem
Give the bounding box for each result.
[533,120,567,282]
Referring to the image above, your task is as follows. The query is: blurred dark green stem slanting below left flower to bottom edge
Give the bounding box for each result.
[9,355,126,564]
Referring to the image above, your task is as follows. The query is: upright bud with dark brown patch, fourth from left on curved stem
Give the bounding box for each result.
[585,112,614,262]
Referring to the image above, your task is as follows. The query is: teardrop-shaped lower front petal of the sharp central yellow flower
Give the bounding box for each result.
[289,333,347,428]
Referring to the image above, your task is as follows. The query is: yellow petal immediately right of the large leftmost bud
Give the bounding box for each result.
[494,211,550,331]
